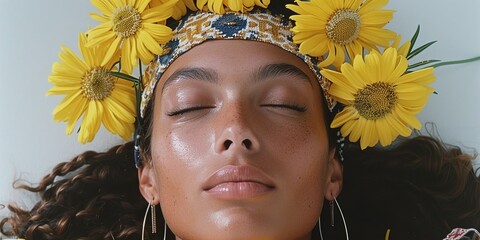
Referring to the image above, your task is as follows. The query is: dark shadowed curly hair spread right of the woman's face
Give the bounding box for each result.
[323,136,480,240]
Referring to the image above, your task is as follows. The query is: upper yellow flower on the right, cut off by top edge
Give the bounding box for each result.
[287,0,396,68]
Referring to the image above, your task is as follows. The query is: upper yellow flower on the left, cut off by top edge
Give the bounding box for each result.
[87,0,178,74]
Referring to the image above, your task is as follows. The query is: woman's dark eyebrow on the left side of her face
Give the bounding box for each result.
[162,67,218,92]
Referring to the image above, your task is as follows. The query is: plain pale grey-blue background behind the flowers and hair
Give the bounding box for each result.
[0,0,480,216]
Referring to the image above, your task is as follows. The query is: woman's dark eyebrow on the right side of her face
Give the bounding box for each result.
[254,63,312,85]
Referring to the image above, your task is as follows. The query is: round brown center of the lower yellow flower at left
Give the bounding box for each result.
[82,67,115,100]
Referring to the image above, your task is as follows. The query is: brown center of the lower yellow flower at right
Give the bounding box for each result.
[354,82,398,120]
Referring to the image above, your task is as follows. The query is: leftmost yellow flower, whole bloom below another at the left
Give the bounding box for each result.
[47,34,135,143]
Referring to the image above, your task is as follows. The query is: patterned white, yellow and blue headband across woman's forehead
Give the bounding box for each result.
[140,11,334,117]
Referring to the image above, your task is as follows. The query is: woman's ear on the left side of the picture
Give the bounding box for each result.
[138,164,159,204]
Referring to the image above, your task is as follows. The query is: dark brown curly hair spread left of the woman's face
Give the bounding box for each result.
[0,142,147,239]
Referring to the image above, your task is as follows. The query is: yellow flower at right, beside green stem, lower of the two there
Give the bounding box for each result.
[321,48,435,149]
